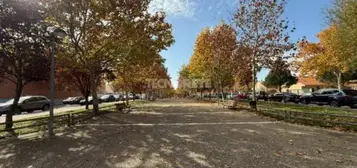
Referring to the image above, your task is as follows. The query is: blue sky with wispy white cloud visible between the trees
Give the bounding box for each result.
[149,0,333,88]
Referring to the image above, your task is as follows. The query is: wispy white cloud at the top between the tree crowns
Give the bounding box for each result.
[149,0,197,18]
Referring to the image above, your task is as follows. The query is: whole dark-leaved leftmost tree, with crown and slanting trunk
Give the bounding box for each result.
[0,0,50,131]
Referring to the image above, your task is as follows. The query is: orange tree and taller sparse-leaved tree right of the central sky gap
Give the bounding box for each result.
[180,0,295,108]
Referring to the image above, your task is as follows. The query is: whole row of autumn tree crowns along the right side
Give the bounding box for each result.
[180,0,357,105]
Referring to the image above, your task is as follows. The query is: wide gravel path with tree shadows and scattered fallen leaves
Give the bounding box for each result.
[0,100,357,168]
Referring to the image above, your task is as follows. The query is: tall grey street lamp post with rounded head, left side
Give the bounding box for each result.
[48,28,67,137]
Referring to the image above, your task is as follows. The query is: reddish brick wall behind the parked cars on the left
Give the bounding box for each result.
[0,80,82,99]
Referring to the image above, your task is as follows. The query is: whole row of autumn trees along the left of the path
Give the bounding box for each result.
[0,0,174,129]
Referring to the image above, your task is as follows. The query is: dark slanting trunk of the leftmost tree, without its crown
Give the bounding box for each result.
[5,80,23,133]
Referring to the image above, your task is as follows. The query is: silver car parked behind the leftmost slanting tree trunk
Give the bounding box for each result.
[0,96,50,115]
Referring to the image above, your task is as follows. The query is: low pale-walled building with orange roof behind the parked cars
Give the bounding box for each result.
[282,77,329,95]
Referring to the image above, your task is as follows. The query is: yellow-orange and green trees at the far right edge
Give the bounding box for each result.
[294,0,357,88]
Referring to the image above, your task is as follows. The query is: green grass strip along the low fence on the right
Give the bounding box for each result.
[232,101,357,131]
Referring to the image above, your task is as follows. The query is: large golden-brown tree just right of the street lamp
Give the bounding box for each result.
[44,0,173,115]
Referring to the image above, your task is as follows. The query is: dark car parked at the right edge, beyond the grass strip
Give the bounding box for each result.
[300,89,357,107]
